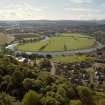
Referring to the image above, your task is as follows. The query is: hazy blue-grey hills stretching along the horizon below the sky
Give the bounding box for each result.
[0,20,105,28]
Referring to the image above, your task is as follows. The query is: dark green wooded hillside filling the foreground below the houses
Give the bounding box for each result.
[0,55,105,105]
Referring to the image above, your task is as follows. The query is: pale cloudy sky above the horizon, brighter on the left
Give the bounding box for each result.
[0,0,105,20]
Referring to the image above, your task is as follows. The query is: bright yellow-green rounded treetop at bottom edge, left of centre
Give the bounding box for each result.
[22,90,40,105]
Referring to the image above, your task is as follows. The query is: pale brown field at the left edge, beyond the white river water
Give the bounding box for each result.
[0,33,14,45]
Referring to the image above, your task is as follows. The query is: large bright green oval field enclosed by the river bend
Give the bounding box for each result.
[17,33,96,52]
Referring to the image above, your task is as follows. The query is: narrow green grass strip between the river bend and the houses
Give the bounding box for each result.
[52,55,89,63]
